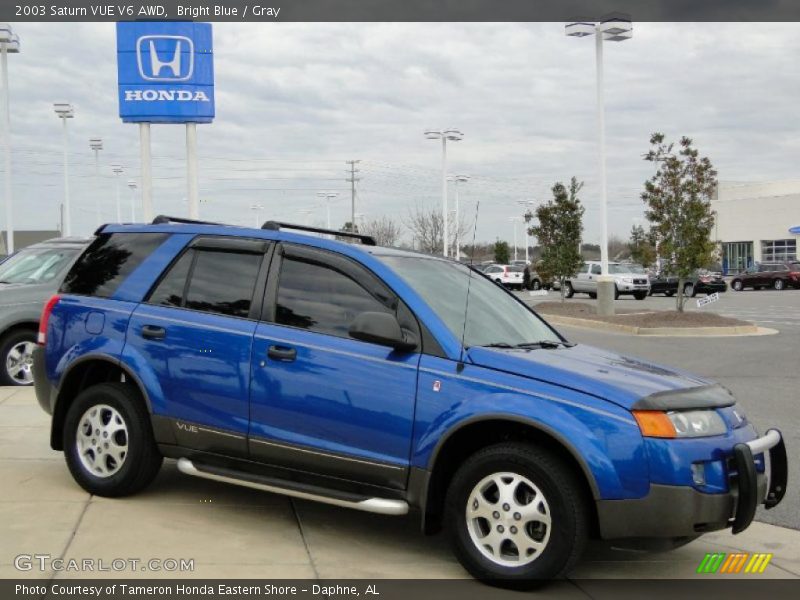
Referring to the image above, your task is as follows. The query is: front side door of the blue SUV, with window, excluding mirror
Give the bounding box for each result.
[249,244,420,489]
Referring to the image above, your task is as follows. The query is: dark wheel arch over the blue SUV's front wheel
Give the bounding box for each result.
[414,414,601,533]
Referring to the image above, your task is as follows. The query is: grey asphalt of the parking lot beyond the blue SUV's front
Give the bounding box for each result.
[521,290,800,529]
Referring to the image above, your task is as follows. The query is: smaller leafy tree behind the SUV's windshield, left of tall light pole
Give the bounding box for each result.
[525,177,585,302]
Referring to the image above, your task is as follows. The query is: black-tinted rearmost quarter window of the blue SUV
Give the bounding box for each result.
[61,233,169,298]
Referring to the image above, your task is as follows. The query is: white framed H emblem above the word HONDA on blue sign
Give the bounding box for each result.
[136,35,194,81]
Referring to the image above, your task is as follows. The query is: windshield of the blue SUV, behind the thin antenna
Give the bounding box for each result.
[378,256,561,347]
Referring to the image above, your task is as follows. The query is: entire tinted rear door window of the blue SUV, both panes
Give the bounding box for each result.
[148,250,263,317]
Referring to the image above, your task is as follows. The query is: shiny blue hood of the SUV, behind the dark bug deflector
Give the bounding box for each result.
[467,344,711,410]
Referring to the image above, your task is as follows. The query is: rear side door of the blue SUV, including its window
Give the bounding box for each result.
[124,237,270,456]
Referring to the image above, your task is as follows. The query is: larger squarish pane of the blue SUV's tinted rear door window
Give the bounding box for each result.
[183,250,262,317]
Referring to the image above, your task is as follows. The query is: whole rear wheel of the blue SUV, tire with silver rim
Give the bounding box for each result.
[64,383,163,497]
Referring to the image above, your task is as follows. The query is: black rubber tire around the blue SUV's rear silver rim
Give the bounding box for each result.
[63,383,163,498]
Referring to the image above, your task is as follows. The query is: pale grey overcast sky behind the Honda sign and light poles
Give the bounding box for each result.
[0,23,800,243]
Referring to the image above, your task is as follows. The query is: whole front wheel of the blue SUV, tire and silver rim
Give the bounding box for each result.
[445,443,588,589]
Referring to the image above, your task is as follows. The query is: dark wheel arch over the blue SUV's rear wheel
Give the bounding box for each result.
[50,354,153,450]
